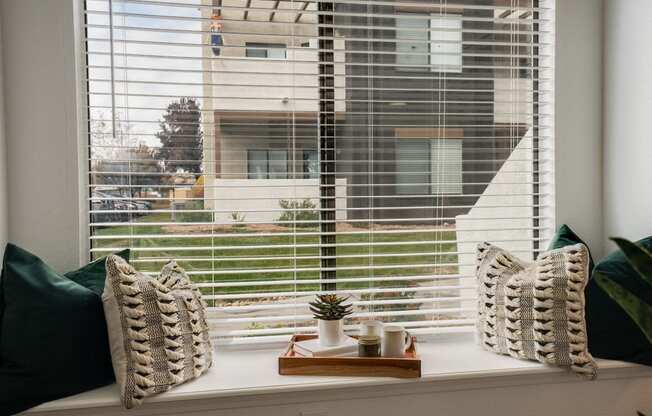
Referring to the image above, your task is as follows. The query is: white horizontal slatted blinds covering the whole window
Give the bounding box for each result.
[86,0,554,341]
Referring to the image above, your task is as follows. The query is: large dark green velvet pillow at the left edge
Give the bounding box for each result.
[0,244,128,415]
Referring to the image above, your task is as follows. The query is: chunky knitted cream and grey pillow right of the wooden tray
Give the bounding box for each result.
[477,243,597,379]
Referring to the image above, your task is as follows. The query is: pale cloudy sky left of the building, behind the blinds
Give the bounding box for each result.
[87,0,203,155]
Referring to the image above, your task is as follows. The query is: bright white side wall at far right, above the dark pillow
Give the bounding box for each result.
[604,0,652,250]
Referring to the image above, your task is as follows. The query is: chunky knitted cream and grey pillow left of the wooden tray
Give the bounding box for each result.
[102,256,212,409]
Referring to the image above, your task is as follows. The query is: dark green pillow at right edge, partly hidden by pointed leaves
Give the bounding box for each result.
[585,236,652,365]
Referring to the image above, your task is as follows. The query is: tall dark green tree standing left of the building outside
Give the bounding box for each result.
[156,97,204,175]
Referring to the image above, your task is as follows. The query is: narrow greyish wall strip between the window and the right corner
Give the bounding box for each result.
[555,0,608,257]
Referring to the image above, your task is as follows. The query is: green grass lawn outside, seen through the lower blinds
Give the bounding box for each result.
[93,213,457,302]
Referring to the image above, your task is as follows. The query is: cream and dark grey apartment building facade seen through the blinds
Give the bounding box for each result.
[203,0,536,224]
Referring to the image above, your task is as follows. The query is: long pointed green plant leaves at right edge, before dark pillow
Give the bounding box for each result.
[594,238,652,344]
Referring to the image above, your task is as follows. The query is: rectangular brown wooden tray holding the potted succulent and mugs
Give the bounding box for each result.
[278,335,421,378]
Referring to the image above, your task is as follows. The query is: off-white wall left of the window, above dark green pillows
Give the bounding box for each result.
[2,0,80,270]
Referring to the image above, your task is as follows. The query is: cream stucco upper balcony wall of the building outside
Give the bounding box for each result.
[202,0,346,113]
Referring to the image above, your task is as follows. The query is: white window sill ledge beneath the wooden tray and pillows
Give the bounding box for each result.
[28,335,652,414]
